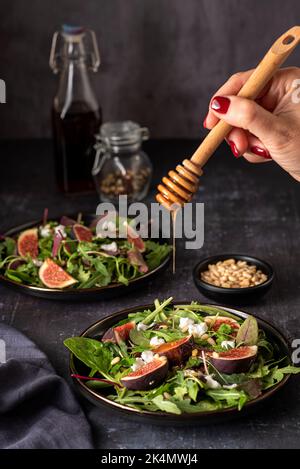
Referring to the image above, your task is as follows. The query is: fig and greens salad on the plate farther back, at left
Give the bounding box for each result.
[0,216,172,289]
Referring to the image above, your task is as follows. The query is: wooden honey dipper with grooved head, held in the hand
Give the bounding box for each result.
[156,26,300,210]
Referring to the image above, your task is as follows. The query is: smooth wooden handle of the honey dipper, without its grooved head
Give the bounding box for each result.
[191,26,300,167]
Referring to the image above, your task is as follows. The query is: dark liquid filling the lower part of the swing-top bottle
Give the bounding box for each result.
[52,102,102,193]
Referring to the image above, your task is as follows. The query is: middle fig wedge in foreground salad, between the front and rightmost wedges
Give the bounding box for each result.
[152,335,193,366]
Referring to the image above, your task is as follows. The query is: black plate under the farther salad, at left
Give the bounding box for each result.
[0,214,171,301]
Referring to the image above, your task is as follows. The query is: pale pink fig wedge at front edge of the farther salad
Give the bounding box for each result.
[39,259,77,288]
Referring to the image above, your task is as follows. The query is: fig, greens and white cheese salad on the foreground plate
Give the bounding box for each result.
[64,298,300,414]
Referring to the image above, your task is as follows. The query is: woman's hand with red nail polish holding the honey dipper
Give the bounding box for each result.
[203,67,300,181]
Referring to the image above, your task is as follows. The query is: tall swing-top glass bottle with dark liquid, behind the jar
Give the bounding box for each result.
[50,25,102,193]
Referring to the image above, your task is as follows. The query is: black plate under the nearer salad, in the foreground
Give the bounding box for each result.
[70,301,290,425]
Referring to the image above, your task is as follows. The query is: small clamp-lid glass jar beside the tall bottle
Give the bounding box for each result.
[92,121,152,203]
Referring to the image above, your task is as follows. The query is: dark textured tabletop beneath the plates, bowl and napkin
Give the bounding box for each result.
[0,140,300,448]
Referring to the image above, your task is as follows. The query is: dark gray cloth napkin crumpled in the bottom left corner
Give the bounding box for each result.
[0,324,93,449]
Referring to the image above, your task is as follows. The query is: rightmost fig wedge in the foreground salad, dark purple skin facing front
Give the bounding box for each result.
[207,345,257,375]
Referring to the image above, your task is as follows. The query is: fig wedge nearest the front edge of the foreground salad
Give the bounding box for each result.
[121,357,169,391]
